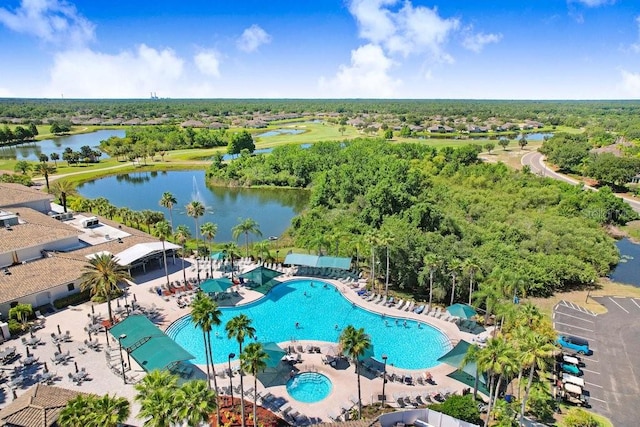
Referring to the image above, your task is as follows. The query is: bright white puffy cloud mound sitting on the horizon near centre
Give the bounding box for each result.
[319,44,402,98]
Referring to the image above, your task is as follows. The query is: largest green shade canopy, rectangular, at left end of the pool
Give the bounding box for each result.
[109,315,194,372]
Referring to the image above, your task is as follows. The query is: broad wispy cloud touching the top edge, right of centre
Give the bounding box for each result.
[349,0,460,62]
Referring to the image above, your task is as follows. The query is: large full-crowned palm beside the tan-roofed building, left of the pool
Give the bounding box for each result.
[80,253,132,324]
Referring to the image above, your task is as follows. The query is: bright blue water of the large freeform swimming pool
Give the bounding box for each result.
[166,280,451,369]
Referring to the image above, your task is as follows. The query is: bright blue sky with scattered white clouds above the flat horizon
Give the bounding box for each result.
[0,0,640,99]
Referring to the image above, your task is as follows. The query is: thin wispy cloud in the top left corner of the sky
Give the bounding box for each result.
[0,0,95,46]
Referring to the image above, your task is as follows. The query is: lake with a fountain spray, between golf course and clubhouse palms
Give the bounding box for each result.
[78,171,309,244]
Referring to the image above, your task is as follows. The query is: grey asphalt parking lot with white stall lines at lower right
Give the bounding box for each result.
[553,297,640,426]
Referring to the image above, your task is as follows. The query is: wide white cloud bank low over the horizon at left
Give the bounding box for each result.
[44,44,184,98]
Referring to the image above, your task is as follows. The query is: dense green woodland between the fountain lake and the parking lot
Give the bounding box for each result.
[209,140,636,301]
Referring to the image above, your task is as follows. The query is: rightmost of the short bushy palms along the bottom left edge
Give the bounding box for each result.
[175,380,220,426]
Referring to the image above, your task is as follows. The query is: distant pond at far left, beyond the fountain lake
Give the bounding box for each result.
[0,129,125,160]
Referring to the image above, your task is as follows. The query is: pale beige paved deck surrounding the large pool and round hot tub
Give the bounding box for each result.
[0,263,474,425]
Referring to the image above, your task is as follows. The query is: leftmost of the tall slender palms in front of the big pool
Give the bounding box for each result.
[191,292,222,425]
